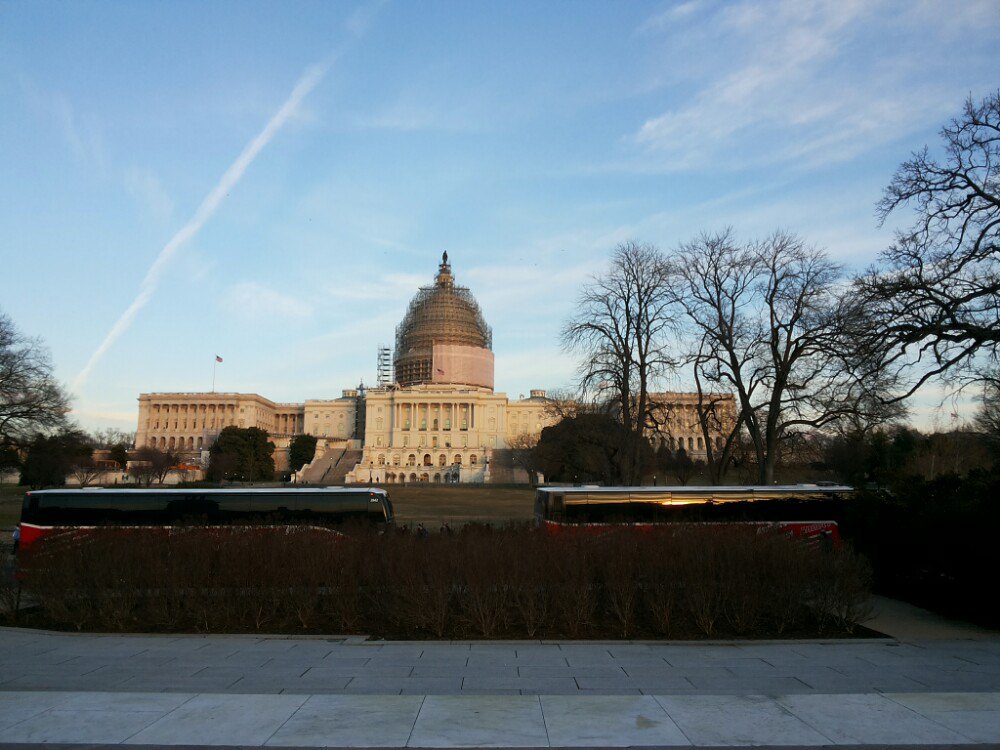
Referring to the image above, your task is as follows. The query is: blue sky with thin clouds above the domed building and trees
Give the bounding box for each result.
[0,0,1000,429]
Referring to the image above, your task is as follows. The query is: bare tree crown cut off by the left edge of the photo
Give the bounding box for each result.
[0,313,69,446]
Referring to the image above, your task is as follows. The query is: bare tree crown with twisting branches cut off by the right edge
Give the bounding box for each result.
[855,91,1000,399]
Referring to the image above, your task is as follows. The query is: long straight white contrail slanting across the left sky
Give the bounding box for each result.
[71,64,329,392]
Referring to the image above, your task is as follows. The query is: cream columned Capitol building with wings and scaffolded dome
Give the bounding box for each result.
[135,253,732,484]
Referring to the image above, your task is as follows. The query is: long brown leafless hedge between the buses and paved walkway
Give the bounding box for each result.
[0,526,871,639]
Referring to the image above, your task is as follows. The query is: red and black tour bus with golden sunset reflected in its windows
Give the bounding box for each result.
[535,484,853,544]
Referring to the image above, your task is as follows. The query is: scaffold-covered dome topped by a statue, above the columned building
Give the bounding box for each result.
[393,253,493,390]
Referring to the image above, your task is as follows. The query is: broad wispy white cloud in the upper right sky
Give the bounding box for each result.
[631,0,988,170]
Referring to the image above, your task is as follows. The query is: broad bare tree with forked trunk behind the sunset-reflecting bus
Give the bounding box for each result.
[669,230,880,484]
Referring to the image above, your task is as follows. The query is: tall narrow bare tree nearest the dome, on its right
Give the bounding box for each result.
[562,242,675,485]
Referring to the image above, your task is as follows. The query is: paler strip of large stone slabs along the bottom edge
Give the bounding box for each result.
[0,693,1000,748]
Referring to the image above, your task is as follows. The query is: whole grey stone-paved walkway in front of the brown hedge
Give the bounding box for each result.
[0,629,1000,747]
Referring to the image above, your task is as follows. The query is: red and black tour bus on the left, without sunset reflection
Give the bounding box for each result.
[21,487,394,549]
